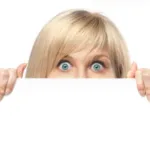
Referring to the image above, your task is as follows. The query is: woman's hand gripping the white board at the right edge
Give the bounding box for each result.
[127,63,150,101]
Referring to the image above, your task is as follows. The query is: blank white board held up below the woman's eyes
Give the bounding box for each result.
[0,79,150,150]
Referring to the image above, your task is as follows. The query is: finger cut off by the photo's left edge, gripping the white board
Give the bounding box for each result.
[0,69,9,99]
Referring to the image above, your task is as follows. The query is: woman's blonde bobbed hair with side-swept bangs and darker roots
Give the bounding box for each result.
[26,10,130,78]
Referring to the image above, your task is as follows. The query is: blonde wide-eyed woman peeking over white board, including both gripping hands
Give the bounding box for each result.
[0,10,150,100]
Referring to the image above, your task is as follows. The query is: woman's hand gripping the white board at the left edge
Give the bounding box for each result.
[0,64,27,100]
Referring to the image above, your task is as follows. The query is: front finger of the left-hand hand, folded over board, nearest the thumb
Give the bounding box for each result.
[5,69,17,95]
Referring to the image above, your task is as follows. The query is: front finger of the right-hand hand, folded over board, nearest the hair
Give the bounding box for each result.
[135,70,146,96]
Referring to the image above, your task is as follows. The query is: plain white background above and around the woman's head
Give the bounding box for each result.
[0,0,150,68]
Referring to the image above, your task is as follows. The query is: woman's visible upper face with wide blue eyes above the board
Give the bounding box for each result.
[48,50,115,78]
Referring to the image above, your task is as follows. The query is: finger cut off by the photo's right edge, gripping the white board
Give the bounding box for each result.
[143,69,150,101]
